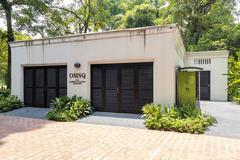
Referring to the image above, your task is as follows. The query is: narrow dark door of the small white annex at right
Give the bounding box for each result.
[196,71,210,100]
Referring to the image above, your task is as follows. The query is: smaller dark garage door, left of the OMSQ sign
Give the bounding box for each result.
[24,66,67,107]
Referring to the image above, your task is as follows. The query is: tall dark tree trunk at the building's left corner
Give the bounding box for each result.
[1,0,14,89]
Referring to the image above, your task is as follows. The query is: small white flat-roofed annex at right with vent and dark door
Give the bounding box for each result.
[186,51,228,101]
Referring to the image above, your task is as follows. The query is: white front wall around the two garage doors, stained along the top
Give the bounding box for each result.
[11,26,181,104]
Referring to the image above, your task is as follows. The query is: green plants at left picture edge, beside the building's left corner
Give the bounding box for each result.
[0,88,24,112]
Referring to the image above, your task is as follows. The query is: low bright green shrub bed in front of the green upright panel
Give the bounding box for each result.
[143,104,216,134]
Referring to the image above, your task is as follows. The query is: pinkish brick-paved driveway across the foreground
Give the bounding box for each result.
[0,116,240,160]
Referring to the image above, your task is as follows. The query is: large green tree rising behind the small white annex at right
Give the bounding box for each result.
[152,0,239,53]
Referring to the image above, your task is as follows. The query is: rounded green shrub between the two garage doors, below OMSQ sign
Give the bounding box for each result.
[48,96,93,122]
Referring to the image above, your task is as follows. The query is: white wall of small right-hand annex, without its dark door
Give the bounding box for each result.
[187,51,228,101]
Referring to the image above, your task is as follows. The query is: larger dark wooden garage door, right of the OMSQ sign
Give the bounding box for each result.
[91,63,153,113]
